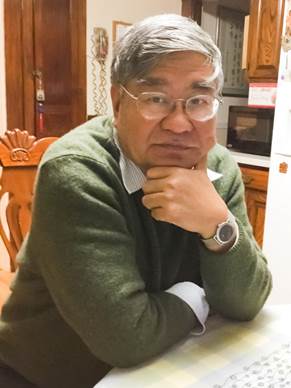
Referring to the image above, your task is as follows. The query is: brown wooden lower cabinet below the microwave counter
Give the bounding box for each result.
[240,165,269,247]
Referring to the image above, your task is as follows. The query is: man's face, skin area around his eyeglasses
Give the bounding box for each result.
[111,52,216,171]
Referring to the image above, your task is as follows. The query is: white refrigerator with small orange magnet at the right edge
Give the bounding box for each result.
[263,0,291,303]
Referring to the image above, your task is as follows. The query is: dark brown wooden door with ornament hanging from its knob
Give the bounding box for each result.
[4,0,87,138]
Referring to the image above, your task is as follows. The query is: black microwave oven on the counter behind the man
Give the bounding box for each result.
[226,106,274,156]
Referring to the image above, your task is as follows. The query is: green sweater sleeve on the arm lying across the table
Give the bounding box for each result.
[27,156,200,367]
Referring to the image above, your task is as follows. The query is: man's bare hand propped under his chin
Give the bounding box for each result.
[142,157,228,238]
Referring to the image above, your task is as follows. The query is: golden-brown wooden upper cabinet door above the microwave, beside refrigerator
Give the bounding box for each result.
[247,0,284,82]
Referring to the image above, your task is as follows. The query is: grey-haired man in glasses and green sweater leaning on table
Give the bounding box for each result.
[0,15,271,388]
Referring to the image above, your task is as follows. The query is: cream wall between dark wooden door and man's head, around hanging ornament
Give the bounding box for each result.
[87,0,182,115]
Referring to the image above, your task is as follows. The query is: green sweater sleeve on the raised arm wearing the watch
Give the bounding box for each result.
[201,147,272,320]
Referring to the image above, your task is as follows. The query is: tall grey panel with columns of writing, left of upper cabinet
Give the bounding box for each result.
[217,7,248,97]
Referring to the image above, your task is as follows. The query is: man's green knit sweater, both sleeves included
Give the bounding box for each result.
[0,117,271,388]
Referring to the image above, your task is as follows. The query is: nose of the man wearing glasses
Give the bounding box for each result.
[162,100,193,133]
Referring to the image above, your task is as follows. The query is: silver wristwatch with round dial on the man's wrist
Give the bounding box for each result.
[201,212,238,253]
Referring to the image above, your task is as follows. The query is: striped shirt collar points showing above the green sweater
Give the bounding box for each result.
[113,129,222,194]
